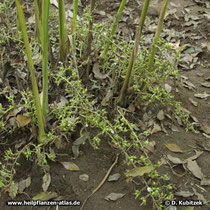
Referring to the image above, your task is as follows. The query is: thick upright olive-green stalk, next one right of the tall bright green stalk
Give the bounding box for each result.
[58,0,67,63]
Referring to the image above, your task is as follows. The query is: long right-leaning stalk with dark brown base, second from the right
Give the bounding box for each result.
[118,0,150,106]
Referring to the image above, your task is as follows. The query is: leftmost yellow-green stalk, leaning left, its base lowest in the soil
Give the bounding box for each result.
[15,0,45,143]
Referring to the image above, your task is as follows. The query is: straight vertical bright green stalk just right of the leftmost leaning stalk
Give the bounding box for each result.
[42,0,50,122]
